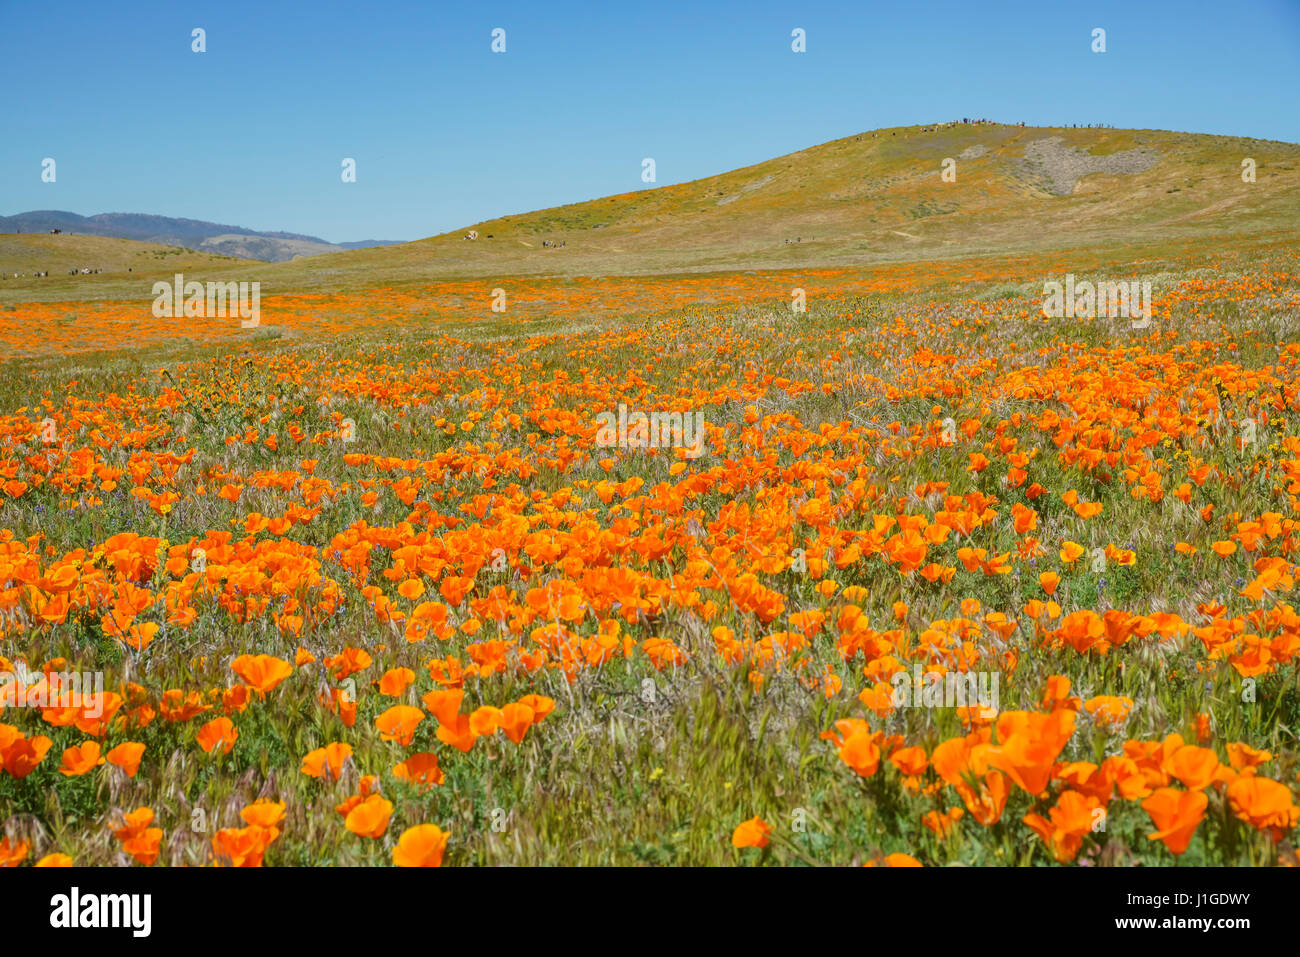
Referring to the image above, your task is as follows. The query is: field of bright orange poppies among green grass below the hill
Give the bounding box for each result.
[0,243,1300,866]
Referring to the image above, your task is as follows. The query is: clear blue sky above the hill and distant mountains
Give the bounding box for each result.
[0,0,1300,242]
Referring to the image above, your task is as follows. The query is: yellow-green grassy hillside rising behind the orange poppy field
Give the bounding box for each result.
[0,126,1300,302]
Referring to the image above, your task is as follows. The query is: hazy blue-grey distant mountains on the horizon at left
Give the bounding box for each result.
[0,209,402,263]
